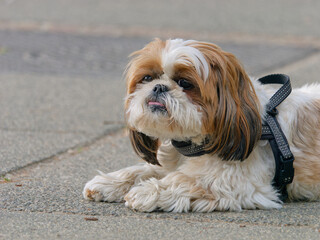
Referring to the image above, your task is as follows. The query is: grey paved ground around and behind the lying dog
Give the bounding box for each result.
[0,0,320,240]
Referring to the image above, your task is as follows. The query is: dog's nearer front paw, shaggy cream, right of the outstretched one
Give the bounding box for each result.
[124,178,160,212]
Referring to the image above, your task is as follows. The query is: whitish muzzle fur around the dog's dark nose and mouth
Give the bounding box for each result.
[127,75,202,140]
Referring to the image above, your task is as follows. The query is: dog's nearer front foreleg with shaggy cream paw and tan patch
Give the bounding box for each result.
[125,172,214,212]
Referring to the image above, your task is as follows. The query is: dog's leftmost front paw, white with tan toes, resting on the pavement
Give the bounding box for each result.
[83,174,132,202]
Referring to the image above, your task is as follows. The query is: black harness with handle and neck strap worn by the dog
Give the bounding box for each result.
[171,74,294,201]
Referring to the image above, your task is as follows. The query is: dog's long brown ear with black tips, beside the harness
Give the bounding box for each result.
[198,44,262,161]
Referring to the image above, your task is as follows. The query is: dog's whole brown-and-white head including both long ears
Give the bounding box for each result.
[125,39,261,164]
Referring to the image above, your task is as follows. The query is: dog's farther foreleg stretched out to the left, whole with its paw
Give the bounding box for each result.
[83,163,168,202]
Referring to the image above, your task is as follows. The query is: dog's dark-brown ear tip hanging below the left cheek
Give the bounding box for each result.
[129,129,161,166]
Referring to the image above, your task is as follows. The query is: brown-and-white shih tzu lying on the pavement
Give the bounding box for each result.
[83,39,320,212]
